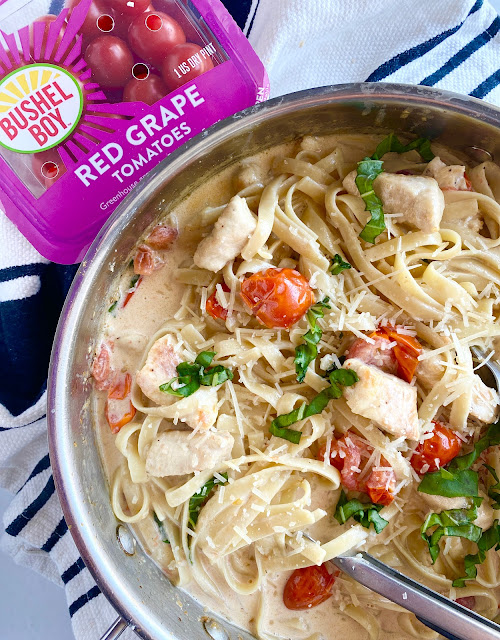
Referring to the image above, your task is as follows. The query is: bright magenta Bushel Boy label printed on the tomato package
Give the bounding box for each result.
[0,0,269,263]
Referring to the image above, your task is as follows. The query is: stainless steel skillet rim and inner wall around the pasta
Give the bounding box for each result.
[48,84,500,640]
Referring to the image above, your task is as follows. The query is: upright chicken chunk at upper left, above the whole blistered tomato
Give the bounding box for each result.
[193,196,257,272]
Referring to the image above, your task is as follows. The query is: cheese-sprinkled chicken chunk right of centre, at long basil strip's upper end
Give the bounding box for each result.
[344,358,420,440]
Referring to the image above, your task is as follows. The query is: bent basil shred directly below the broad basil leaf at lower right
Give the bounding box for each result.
[420,505,483,564]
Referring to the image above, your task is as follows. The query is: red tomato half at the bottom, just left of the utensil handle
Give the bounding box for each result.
[283,564,340,610]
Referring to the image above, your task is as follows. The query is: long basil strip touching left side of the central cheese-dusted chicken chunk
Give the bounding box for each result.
[269,369,359,444]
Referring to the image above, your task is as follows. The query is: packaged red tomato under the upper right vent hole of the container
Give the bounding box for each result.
[128,11,186,68]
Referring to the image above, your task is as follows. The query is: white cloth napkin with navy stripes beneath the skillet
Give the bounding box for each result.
[0,0,500,640]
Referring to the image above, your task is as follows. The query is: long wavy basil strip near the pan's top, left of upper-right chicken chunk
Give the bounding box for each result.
[356,133,434,243]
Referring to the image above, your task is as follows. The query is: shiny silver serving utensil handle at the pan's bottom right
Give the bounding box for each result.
[304,532,500,640]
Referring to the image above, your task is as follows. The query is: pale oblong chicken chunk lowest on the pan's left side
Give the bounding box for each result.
[146,431,234,478]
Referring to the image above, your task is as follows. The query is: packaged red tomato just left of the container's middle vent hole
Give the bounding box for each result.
[85,35,134,87]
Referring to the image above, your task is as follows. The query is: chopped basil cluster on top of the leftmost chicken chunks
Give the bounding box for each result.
[159,351,233,398]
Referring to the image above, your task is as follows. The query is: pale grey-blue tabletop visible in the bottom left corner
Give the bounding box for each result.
[0,0,500,640]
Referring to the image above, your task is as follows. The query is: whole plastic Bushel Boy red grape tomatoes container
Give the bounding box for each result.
[0,0,269,263]
